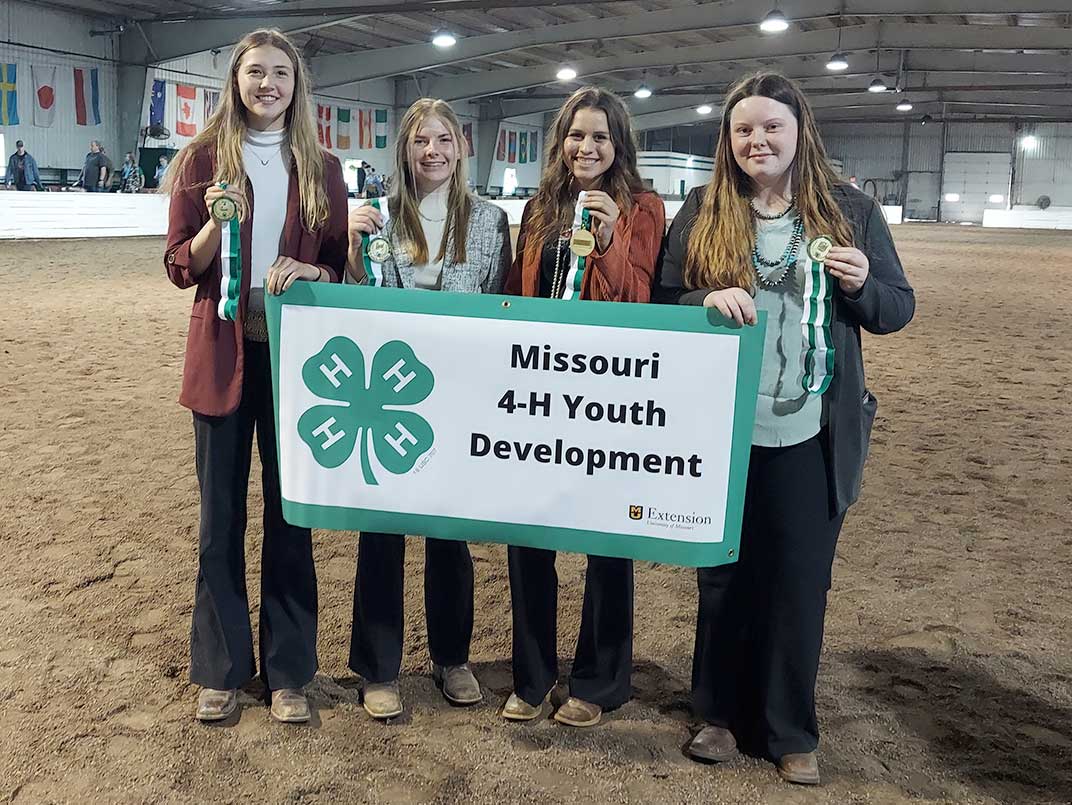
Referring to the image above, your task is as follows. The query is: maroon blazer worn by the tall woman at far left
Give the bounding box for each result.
[164,149,347,416]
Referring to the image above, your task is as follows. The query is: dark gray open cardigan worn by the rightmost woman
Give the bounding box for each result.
[653,184,915,513]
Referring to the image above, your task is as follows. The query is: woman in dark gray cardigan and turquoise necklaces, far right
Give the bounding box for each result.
[654,73,915,785]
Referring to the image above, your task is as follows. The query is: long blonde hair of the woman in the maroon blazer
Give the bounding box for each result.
[161,28,330,232]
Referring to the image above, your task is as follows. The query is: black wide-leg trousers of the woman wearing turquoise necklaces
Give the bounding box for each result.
[693,434,845,760]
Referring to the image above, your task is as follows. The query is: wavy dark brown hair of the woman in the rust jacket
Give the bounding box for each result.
[528,87,644,243]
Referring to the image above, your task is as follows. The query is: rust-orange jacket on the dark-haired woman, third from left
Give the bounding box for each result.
[503,192,666,302]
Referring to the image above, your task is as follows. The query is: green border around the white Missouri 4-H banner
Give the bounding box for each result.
[272,282,766,567]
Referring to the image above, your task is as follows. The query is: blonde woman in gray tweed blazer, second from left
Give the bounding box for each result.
[346,99,511,719]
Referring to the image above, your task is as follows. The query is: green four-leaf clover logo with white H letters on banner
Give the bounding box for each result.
[298,336,435,486]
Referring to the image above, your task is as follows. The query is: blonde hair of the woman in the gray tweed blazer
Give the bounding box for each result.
[388,98,473,266]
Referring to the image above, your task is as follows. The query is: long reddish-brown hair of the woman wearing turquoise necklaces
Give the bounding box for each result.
[684,72,852,288]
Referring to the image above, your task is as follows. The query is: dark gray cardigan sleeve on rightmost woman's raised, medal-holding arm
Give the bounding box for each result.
[842,194,915,336]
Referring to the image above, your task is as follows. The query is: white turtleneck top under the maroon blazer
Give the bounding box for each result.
[242,129,291,310]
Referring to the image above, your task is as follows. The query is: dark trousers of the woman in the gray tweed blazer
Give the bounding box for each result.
[349,533,473,683]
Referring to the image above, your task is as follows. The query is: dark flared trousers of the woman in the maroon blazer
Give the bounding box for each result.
[190,341,316,690]
